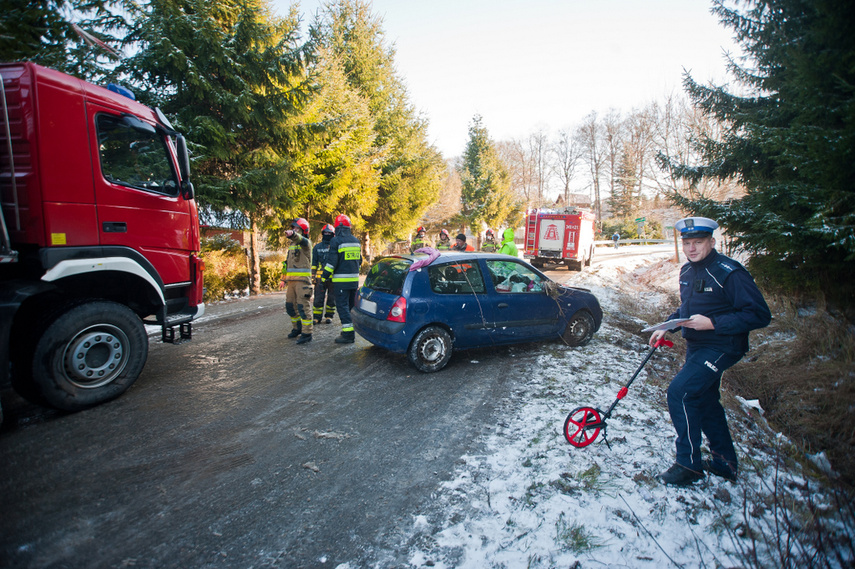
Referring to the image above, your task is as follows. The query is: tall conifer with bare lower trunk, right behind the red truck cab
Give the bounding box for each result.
[123,0,319,292]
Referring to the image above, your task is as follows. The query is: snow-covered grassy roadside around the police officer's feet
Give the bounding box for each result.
[382,248,853,569]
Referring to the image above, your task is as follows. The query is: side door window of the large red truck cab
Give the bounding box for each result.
[96,114,178,195]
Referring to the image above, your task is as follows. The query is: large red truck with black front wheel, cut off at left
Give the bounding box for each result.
[0,63,204,411]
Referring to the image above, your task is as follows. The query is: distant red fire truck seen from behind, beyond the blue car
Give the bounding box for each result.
[524,208,596,271]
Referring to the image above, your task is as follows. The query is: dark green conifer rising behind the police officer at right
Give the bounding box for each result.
[671,0,855,305]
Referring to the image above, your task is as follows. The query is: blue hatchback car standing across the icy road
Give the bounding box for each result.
[352,252,603,372]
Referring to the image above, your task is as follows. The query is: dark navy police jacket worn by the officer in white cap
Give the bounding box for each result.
[668,249,772,357]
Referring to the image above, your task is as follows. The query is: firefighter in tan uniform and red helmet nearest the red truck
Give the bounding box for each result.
[284,217,312,344]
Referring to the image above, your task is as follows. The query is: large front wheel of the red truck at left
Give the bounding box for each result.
[30,300,148,411]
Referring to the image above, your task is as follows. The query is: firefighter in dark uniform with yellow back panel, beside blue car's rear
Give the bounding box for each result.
[321,214,362,344]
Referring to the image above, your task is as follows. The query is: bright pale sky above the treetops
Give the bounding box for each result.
[280,0,738,158]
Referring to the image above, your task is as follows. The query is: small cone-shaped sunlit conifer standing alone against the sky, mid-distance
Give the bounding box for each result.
[458,115,520,227]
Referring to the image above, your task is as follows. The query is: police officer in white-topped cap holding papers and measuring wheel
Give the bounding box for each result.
[649,217,772,486]
